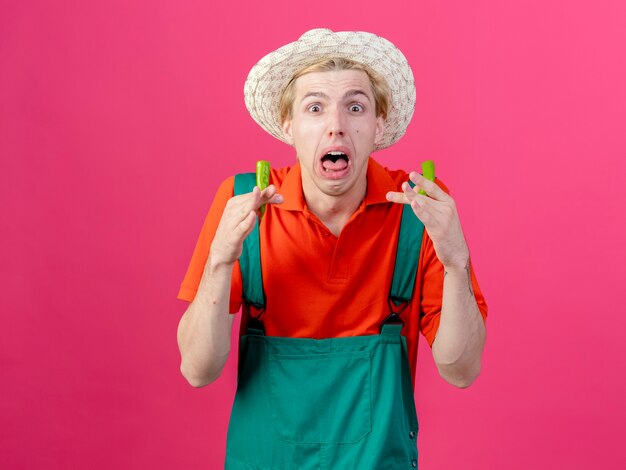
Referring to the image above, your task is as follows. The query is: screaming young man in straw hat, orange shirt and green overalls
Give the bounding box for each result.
[178,29,487,469]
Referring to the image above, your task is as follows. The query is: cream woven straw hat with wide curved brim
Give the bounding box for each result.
[243,29,415,150]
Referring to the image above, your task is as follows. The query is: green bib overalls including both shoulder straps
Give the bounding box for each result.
[225,173,424,470]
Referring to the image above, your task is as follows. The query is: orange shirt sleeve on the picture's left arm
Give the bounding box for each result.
[178,177,242,313]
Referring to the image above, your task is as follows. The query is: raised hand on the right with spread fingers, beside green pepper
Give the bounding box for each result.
[387,172,469,271]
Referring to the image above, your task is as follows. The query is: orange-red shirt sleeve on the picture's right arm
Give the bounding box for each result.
[420,179,487,347]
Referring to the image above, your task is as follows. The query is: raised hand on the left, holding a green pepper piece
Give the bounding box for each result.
[209,184,283,266]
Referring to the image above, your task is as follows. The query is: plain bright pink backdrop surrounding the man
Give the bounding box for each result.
[0,0,626,470]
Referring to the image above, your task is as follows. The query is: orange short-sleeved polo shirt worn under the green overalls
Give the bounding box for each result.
[178,158,487,386]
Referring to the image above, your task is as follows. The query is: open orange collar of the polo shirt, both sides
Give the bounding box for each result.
[275,157,398,211]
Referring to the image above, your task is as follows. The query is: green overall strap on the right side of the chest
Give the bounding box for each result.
[389,182,424,306]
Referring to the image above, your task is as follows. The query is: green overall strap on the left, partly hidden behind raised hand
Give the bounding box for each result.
[235,173,265,310]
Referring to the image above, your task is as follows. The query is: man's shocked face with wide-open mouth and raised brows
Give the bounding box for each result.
[283,70,384,197]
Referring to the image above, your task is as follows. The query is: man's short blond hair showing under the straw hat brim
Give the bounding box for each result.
[279,57,391,123]
